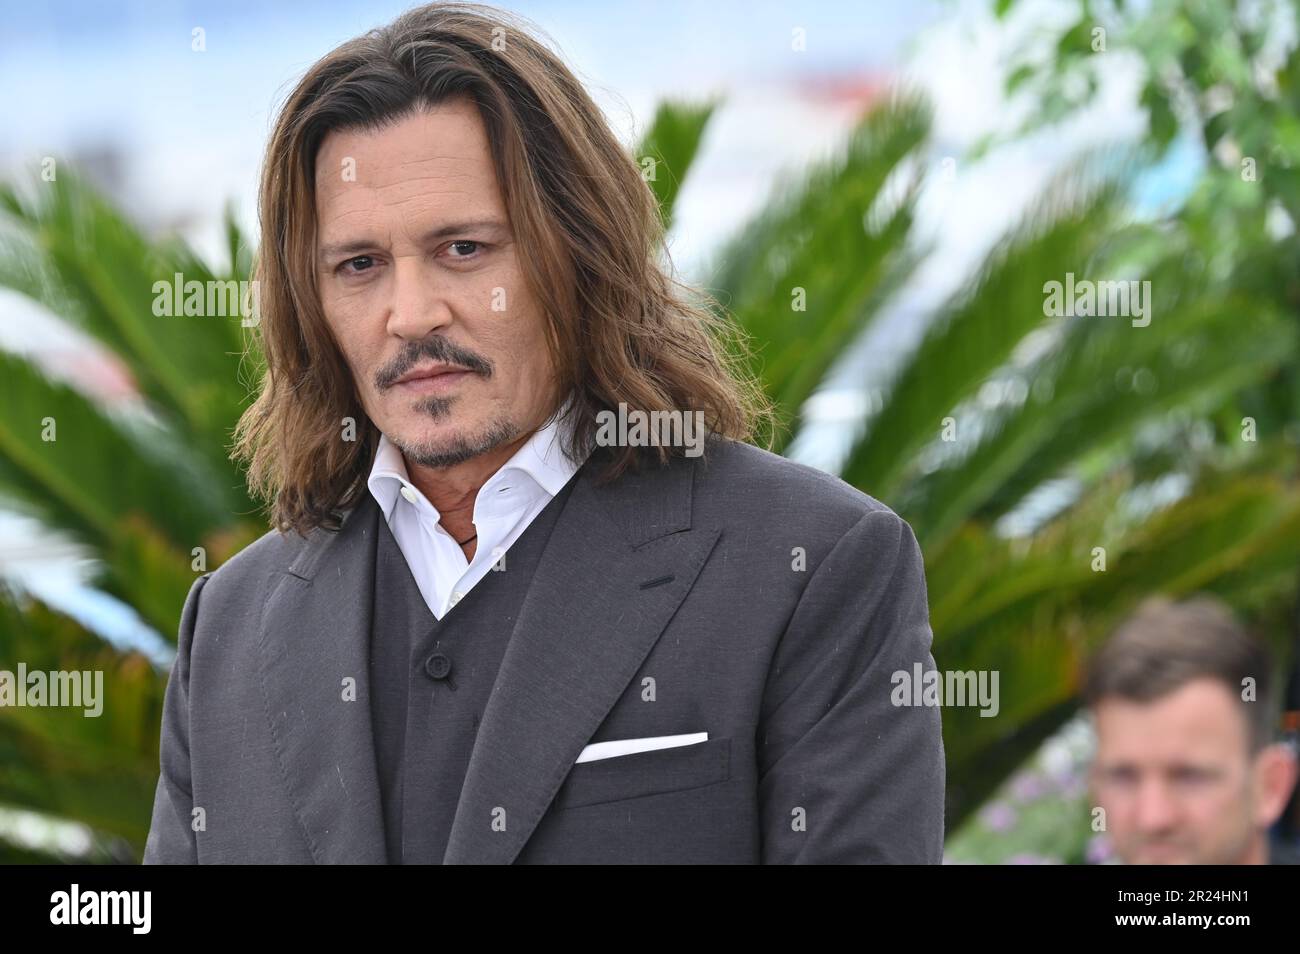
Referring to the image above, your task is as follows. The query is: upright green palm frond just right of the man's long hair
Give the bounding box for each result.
[710,95,931,450]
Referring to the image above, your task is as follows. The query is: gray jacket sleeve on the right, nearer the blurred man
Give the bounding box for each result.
[758,509,946,864]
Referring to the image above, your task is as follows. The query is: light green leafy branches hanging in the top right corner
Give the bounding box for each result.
[1002,0,1300,433]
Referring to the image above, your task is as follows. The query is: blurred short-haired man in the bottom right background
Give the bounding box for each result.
[1084,597,1296,864]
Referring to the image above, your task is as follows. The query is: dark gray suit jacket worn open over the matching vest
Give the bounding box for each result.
[144,441,945,864]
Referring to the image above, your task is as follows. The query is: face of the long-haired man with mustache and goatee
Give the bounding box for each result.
[316,99,553,467]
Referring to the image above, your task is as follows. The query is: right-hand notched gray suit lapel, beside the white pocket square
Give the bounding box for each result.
[443,459,720,864]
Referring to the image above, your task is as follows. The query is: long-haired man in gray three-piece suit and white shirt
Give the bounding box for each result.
[146,4,945,864]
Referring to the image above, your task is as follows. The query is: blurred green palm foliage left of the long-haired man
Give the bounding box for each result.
[0,175,267,860]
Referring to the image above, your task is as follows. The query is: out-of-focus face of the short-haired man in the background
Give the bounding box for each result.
[1092,678,1269,864]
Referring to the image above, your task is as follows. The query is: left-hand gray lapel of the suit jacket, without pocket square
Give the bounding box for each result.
[260,493,386,864]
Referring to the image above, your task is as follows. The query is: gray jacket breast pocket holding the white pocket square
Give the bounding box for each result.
[554,738,731,810]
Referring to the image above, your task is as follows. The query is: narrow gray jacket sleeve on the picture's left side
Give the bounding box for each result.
[144,573,212,864]
